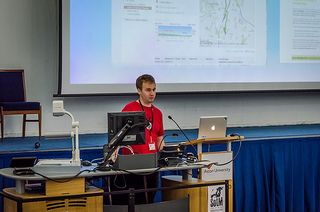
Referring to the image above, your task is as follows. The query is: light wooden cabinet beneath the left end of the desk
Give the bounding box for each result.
[3,177,103,212]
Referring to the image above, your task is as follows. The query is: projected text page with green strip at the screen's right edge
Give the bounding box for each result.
[280,0,320,63]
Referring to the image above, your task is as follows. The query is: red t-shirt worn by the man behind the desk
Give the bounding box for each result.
[122,101,164,154]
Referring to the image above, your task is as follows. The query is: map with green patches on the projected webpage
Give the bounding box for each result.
[200,0,256,48]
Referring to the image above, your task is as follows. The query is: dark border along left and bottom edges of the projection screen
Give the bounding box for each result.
[53,0,320,97]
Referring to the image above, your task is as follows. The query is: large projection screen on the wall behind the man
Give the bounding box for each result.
[57,0,320,96]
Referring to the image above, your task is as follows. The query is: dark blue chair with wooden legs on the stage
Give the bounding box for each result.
[0,70,41,142]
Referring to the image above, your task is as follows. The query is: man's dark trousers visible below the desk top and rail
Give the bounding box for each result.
[109,172,159,205]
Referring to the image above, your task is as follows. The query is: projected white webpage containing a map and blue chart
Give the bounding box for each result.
[112,0,266,66]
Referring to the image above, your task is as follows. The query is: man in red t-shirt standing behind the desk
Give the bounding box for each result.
[110,74,164,205]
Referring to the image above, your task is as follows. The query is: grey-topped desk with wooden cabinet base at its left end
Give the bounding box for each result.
[0,162,209,212]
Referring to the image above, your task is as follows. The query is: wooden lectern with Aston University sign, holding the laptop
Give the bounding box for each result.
[162,136,244,212]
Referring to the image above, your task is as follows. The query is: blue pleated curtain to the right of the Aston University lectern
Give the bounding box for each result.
[232,138,320,212]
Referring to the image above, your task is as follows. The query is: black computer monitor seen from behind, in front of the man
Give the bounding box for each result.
[108,111,146,146]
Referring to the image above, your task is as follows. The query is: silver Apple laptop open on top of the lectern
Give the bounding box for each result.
[198,116,228,139]
